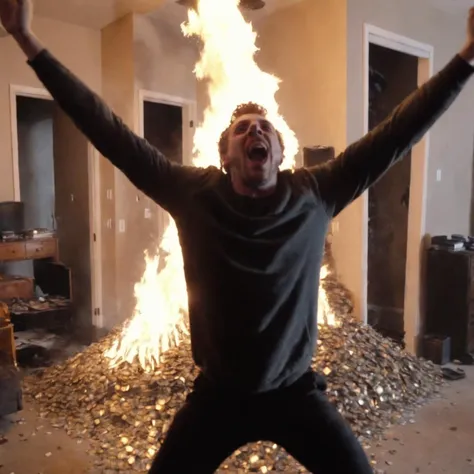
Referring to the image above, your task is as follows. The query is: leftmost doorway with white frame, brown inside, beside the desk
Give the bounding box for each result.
[11,86,101,336]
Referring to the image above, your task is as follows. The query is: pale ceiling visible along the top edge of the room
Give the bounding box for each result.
[33,0,474,29]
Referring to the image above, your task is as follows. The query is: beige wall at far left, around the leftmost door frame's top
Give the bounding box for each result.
[0,18,101,201]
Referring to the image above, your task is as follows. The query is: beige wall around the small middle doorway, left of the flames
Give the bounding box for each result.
[101,13,196,328]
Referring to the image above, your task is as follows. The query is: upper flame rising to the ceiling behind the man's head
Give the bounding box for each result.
[181,0,299,169]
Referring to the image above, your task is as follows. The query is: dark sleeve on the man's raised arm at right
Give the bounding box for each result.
[307,55,474,217]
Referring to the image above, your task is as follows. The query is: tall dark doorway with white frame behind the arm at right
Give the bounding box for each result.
[360,24,434,354]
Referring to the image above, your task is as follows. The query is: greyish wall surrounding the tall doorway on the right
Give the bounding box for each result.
[335,0,474,322]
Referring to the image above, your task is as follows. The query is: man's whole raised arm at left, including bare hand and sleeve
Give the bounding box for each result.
[0,0,197,211]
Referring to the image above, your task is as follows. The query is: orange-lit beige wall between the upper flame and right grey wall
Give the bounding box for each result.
[257,0,347,168]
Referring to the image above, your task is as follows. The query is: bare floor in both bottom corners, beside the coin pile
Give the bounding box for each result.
[0,367,474,474]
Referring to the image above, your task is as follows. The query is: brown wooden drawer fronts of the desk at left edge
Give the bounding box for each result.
[0,237,58,262]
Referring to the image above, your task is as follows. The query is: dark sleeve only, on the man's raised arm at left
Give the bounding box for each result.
[28,50,203,212]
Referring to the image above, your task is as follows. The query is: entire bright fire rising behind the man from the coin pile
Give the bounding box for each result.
[106,0,336,370]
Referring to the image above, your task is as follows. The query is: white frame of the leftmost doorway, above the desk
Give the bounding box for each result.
[10,84,104,328]
